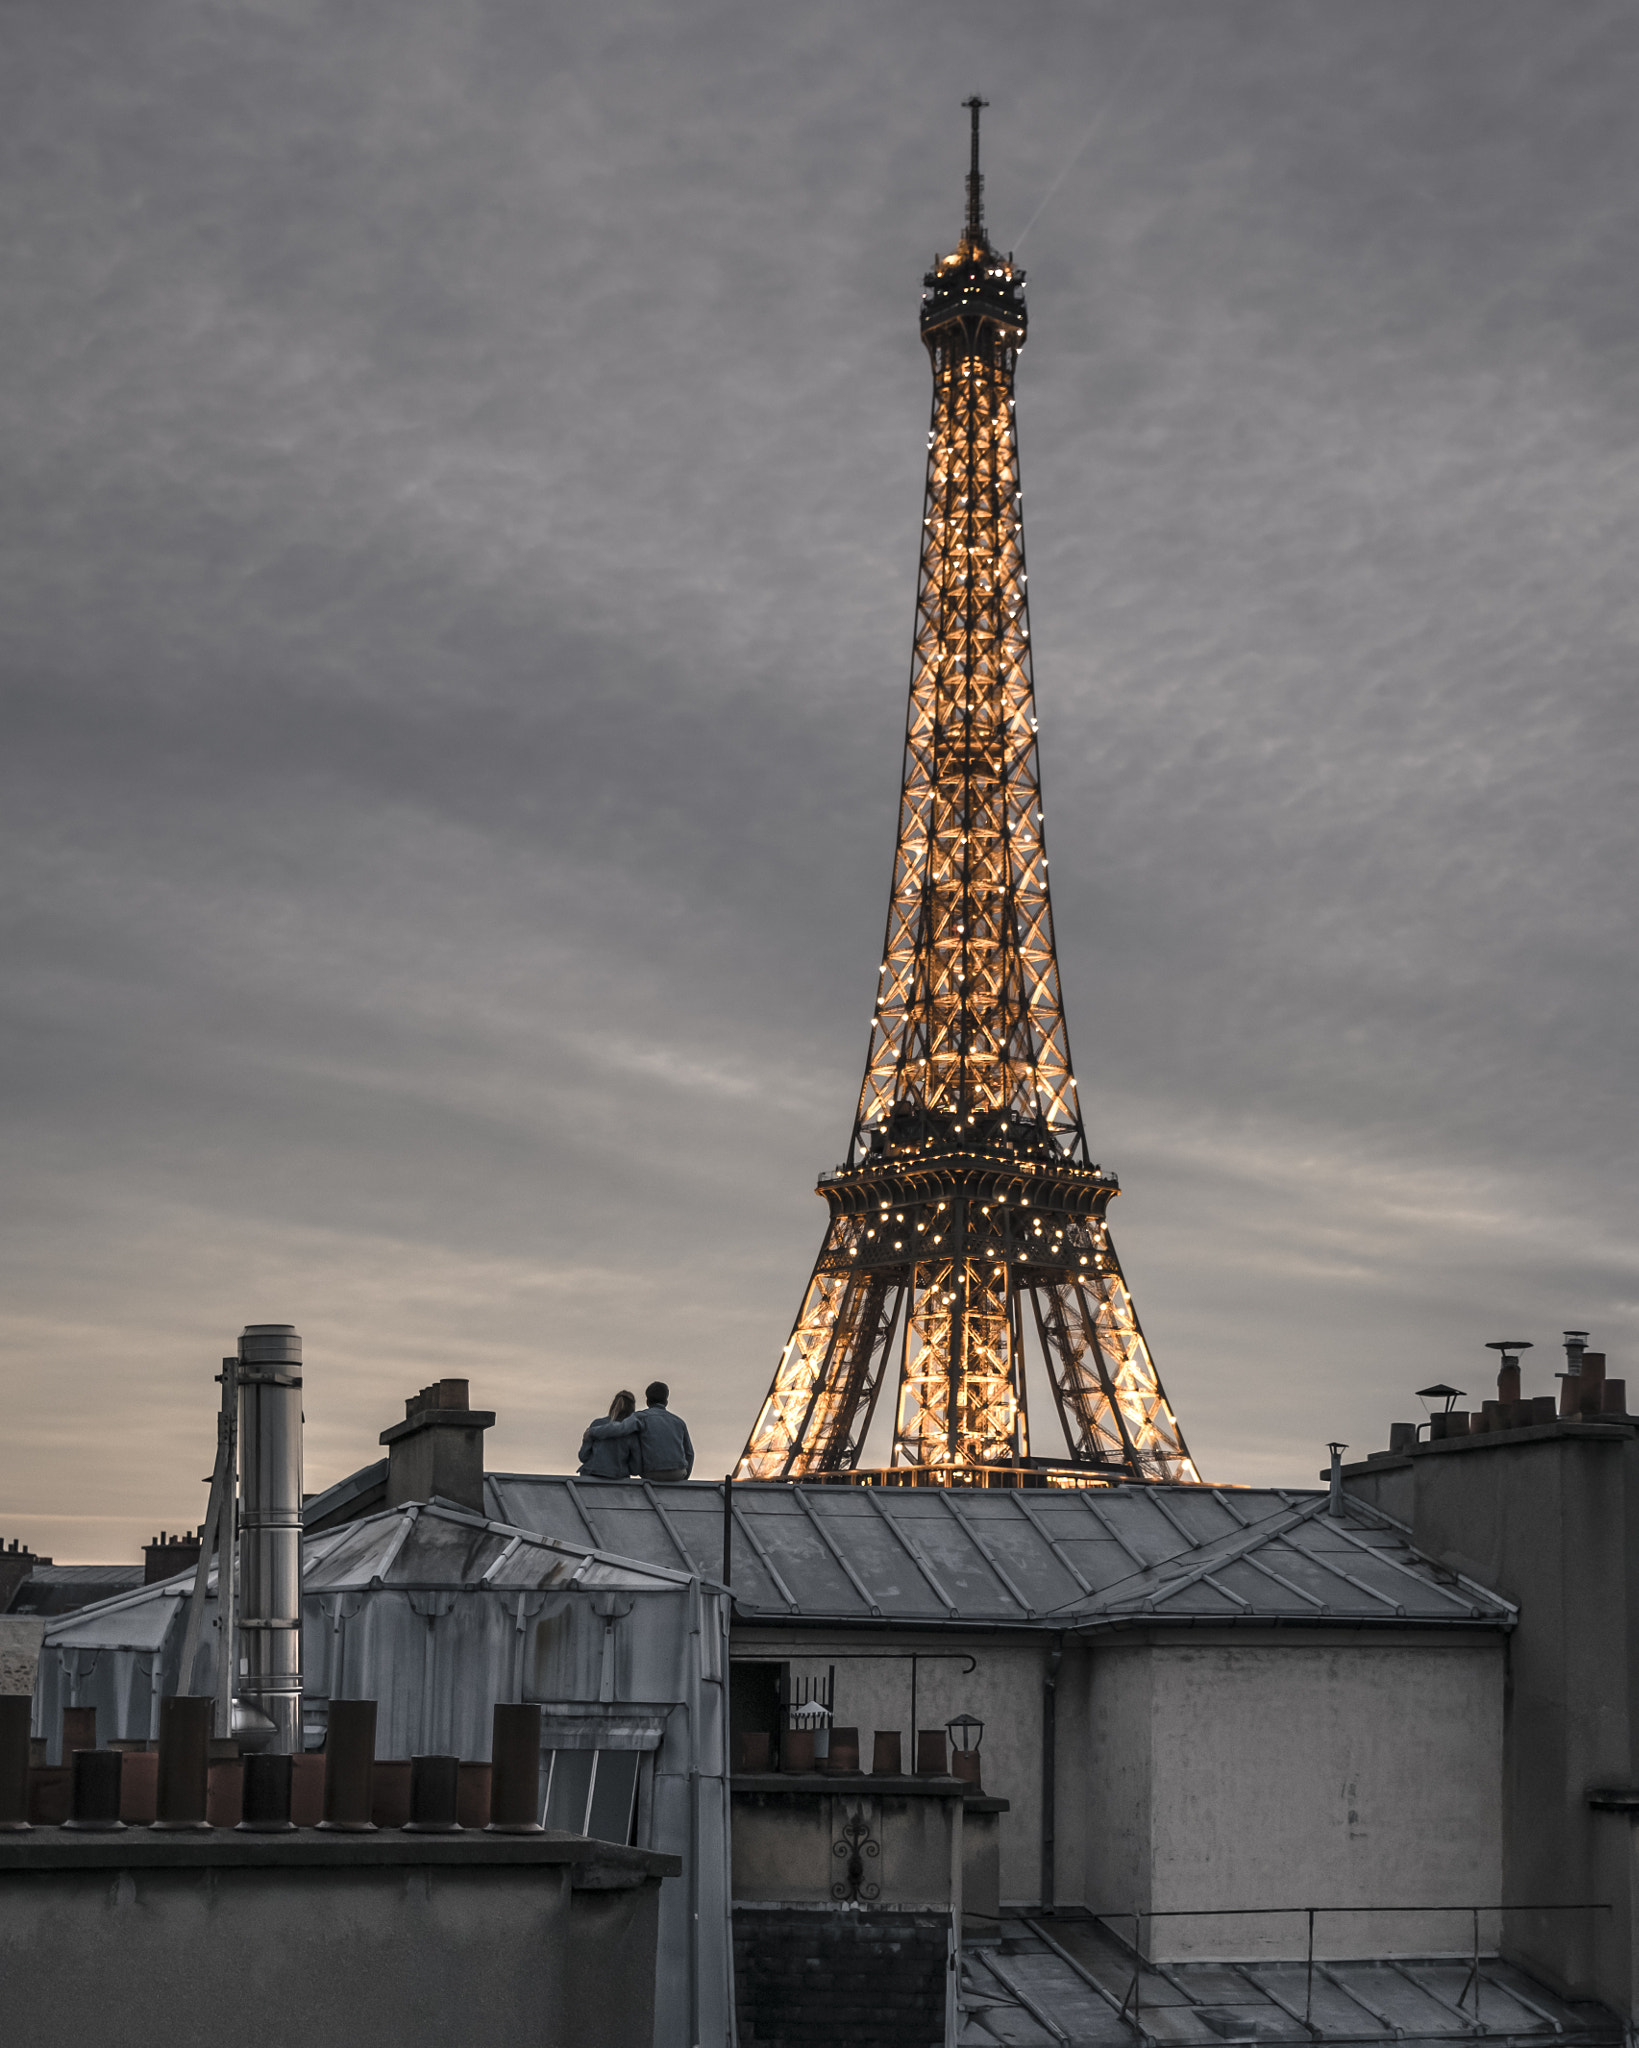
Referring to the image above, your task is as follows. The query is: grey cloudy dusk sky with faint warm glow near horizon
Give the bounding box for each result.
[0,0,1639,1561]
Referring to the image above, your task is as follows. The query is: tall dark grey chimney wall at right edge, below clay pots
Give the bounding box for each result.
[1346,1423,1639,2019]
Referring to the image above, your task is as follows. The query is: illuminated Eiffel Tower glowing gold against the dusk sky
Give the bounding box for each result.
[736,98,1199,1485]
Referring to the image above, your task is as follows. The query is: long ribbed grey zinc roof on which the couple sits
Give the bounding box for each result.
[486,1473,1514,1628]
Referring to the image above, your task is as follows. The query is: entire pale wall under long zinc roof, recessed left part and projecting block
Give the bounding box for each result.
[733,1624,1506,1956]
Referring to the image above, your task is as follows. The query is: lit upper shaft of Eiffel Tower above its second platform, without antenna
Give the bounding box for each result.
[850,238,1086,1157]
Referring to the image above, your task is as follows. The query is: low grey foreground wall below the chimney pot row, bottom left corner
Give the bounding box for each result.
[0,1831,676,2048]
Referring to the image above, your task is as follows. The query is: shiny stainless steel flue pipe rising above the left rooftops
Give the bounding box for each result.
[236,1323,301,1755]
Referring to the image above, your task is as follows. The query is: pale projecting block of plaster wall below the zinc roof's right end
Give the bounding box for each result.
[1065,1634,1504,1958]
